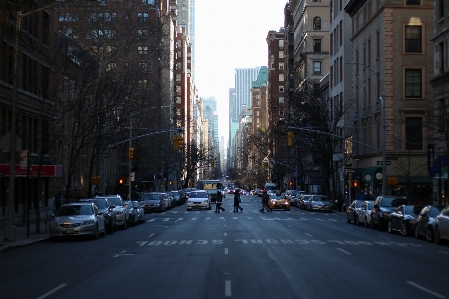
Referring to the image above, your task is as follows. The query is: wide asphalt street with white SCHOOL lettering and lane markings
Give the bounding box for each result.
[0,195,449,299]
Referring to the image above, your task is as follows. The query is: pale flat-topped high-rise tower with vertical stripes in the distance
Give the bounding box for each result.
[234,67,260,120]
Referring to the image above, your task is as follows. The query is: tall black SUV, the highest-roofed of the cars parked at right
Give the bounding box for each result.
[371,196,410,230]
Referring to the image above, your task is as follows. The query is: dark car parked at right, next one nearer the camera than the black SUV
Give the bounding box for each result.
[388,205,423,236]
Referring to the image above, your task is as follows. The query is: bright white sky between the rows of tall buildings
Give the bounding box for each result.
[195,0,288,152]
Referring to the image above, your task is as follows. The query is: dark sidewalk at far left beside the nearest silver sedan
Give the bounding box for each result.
[0,222,48,253]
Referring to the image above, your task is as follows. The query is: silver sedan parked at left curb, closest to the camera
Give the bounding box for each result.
[49,202,106,240]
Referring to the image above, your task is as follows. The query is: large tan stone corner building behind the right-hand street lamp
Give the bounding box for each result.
[344,0,434,200]
